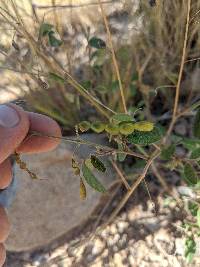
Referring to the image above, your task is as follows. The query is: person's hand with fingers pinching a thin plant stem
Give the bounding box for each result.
[0,104,61,266]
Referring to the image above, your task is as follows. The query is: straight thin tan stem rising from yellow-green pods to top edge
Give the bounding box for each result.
[98,0,127,113]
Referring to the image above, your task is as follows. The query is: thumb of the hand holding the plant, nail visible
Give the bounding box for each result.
[0,104,29,163]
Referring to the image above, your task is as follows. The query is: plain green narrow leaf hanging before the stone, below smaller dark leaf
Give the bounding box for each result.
[82,162,106,193]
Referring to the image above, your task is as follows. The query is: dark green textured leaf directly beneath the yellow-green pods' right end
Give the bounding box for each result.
[127,127,162,146]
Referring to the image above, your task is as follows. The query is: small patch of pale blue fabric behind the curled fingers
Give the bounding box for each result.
[0,177,17,208]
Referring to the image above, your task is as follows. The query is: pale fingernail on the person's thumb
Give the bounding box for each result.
[0,105,20,128]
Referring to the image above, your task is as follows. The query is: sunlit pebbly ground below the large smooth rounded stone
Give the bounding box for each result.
[6,183,200,267]
